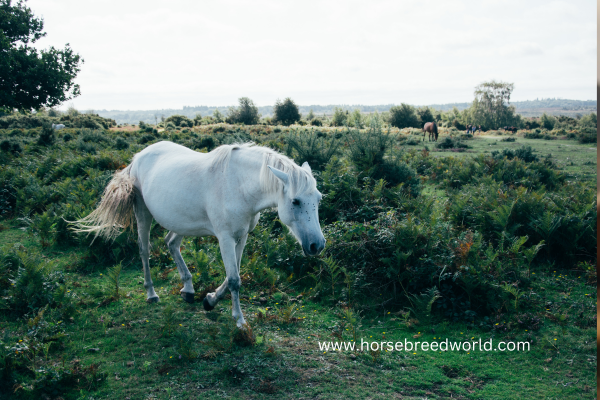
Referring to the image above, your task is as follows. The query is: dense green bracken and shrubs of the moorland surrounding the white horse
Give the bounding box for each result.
[0,102,597,398]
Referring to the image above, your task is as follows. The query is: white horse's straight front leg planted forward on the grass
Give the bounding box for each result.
[219,233,248,328]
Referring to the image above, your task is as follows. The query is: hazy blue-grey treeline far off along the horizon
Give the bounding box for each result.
[94,98,598,124]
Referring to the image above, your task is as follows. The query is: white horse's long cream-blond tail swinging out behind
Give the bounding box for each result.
[72,165,135,240]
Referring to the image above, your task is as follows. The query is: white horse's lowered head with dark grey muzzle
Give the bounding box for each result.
[269,162,325,256]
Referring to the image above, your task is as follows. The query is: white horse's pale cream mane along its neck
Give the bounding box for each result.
[209,142,317,197]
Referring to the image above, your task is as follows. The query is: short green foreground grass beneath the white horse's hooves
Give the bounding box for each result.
[0,224,596,399]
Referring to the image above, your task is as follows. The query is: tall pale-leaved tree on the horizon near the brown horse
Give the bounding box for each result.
[471,80,515,128]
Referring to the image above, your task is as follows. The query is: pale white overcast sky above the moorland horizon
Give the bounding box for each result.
[27,0,597,110]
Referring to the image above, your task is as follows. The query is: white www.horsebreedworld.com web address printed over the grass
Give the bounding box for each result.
[318,339,529,352]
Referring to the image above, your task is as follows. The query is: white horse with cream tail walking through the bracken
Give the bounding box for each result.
[75,141,325,327]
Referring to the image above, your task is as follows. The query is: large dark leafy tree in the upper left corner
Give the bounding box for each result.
[0,0,83,111]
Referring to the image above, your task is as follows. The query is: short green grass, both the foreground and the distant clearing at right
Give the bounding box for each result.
[0,124,597,399]
